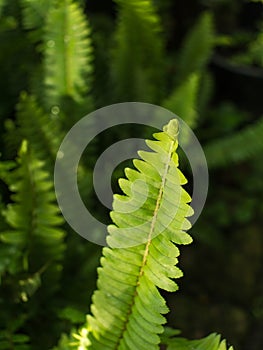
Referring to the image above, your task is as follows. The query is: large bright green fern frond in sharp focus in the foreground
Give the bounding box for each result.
[83,120,193,350]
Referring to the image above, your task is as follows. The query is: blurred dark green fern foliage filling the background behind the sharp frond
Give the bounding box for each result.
[0,0,263,350]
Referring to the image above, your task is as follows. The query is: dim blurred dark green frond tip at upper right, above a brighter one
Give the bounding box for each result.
[177,13,215,83]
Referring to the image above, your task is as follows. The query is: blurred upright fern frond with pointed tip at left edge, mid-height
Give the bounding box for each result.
[0,141,64,286]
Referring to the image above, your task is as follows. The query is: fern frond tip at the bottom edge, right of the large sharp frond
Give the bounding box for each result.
[167,334,234,350]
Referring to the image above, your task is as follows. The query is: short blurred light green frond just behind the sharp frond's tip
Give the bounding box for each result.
[163,74,199,128]
